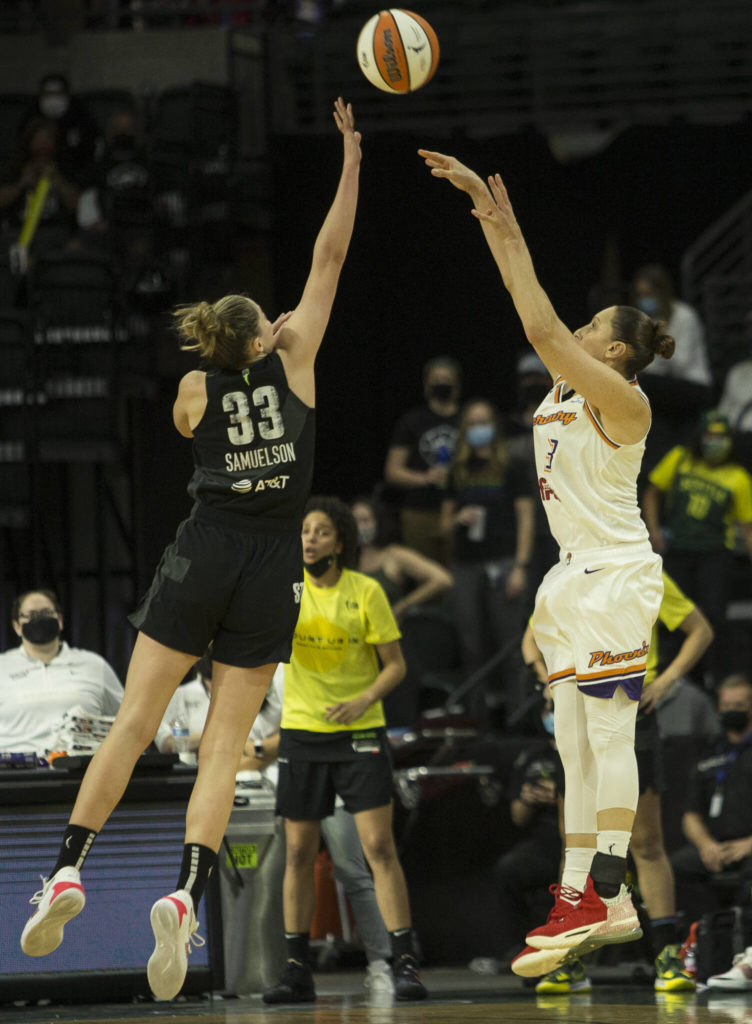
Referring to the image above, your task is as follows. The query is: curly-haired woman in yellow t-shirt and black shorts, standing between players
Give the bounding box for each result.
[263,498,426,1004]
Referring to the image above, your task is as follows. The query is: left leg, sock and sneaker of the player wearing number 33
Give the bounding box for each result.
[20,633,196,956]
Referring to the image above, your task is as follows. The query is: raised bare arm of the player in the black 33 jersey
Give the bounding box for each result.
[277,97,361,372]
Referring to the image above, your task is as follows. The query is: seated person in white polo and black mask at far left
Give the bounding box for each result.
[0,590,123,757]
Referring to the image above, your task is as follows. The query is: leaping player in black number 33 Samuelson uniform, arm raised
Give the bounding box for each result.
[20,98,361,999]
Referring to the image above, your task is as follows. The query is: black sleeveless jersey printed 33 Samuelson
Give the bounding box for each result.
[189,352,315,520]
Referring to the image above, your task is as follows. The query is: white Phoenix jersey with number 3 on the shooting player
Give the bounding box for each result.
[533,377,647,552]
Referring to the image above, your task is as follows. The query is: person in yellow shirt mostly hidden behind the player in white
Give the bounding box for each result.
[523,572,713,994]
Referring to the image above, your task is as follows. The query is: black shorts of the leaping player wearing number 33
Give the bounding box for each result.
[129,516,303,669]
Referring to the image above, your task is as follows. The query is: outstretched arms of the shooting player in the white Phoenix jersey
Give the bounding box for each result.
[418,150,650,443]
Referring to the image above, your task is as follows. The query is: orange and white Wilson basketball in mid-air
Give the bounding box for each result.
[358,7,438,93]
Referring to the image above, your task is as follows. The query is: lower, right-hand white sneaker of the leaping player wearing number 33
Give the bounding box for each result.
[147,889,204,999]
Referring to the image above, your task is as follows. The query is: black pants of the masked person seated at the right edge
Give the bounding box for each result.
[671,844,752,921]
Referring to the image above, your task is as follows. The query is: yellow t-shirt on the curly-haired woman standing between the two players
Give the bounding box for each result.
[282,569,401,732]
